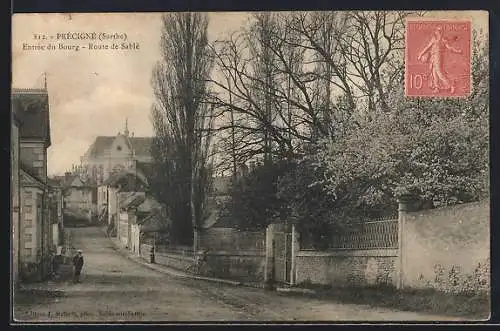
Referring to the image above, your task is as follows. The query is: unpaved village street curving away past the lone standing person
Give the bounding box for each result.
[14,227,464,322]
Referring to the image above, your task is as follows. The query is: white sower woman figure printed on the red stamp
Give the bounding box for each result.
[418,26,462,93]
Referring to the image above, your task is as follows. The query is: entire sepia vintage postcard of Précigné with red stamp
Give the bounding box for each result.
[11,11,490,323]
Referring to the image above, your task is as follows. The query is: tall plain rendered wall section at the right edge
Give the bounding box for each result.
[404,201,490,289]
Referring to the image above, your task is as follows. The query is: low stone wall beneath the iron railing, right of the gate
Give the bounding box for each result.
[296,249,397,286]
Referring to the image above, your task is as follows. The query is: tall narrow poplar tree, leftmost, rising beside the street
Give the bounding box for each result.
[152,13,216,251]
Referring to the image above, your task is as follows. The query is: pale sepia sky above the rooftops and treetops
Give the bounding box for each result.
[12,12,488,175]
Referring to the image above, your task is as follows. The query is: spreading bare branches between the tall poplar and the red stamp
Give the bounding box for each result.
[211,11,409,172]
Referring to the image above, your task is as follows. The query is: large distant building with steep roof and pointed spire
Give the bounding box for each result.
[81,122,153,185]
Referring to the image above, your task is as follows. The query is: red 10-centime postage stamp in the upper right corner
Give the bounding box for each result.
[405,19,472,97]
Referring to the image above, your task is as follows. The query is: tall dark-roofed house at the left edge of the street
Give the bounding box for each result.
[12,89,54,279]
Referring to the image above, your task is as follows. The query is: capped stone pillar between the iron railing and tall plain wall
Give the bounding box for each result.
[396,196,410,289]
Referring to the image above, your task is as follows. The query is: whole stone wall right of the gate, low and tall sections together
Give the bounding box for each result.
[295,200,490,292]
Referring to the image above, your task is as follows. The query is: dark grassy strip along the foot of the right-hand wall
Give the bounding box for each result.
[287,284,491,320]
